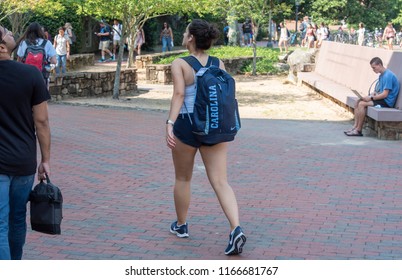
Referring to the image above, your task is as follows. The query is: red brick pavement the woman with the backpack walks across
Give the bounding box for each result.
[24,104,402,260]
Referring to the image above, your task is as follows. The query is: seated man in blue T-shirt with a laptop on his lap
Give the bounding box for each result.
[345,57,399,136]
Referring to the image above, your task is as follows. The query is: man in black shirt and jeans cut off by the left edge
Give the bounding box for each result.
[0,26,50,260]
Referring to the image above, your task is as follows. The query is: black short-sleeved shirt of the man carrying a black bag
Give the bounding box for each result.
[0,60,50,176]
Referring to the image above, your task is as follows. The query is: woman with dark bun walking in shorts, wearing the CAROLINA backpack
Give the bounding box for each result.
[166,19,246,255]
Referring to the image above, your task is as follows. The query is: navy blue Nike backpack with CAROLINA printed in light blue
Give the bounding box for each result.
[182,56,241,145]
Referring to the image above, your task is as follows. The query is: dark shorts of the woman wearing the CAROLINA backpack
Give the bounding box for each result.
[173,113,213,148]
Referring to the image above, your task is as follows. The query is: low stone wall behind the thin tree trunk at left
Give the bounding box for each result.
[49,69,137,100]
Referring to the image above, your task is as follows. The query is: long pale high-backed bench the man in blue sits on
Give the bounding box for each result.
[297,41,402,140]
